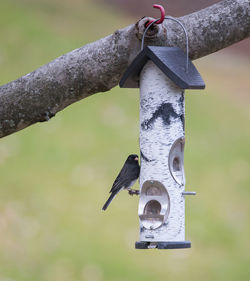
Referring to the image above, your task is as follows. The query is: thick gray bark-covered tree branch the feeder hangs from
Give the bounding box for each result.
[0,0,250,137]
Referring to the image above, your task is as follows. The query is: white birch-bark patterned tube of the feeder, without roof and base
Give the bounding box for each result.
[139,61,185,242]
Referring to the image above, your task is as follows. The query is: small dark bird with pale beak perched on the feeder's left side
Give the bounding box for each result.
[102,154,140,211]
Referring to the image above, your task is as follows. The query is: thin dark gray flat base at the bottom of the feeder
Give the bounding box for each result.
[135,241,191,250]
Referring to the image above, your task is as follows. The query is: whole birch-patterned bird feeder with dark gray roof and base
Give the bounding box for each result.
[120,46,205,249]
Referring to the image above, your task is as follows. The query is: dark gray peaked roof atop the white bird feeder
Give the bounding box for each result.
[119,46,205,89]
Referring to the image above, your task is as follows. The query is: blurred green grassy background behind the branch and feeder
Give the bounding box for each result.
[0,0,250,281]
